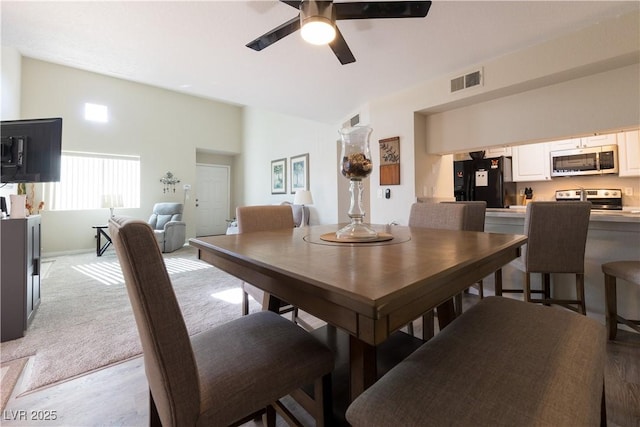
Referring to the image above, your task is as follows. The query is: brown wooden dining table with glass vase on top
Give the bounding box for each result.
[189,224,527,400]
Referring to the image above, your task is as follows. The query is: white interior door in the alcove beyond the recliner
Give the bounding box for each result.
[196,165,230,237]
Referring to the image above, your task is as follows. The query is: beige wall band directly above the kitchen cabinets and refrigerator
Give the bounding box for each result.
[426,64,640,153]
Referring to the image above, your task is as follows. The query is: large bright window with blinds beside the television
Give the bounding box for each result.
[44,152,140,210]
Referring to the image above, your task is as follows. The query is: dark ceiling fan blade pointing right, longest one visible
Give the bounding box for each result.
[333,1,431,19]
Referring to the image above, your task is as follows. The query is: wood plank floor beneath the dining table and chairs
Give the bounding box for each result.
[0,301,640,427]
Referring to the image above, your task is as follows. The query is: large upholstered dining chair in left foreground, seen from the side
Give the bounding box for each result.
[109,217,334,427]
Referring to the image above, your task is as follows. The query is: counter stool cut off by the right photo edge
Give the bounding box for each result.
[602,261,640,340]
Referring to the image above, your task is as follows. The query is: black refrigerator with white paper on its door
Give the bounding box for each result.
[453,156,517,208]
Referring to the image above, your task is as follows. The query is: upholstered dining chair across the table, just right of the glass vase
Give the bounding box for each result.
[407,203,468,340]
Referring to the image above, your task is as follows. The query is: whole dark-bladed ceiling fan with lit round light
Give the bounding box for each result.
[247,0,431,65]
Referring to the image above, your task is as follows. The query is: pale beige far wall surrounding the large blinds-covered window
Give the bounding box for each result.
[21,58,242,253]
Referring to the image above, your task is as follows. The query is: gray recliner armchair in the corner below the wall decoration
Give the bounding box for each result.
[148,203,187,252]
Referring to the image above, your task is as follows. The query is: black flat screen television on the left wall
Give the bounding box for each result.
[0,117,62,183]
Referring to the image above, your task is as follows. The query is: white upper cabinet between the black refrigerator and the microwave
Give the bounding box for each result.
[511,143,551,182]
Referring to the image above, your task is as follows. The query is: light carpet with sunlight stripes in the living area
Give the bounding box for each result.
[0,247,256,392]
